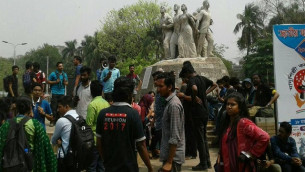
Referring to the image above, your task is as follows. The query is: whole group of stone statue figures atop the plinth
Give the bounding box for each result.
[160,0,214,59]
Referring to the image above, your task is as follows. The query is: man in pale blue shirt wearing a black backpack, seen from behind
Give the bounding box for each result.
[51,96,94,172]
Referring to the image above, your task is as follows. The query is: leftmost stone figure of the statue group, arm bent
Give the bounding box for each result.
[160,6,174,58]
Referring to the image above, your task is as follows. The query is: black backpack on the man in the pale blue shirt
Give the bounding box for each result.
[64,115,95,171]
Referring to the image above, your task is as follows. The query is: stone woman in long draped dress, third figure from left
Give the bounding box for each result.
[178,4,197,58]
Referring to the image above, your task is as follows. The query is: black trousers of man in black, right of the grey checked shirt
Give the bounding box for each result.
[193,118,211,166]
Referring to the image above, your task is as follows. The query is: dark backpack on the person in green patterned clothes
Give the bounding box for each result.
[2,116,33,172]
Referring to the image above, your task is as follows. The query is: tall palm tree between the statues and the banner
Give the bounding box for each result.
[234,3,263,55]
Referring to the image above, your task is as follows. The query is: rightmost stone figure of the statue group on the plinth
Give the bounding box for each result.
[196,0,214,57]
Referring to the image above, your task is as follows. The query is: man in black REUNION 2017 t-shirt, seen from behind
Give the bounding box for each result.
[96,77,153,172]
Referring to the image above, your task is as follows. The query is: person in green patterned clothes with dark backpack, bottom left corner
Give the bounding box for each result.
[0,96,57,172]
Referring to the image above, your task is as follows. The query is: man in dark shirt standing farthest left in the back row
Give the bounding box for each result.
[3,65,19,97]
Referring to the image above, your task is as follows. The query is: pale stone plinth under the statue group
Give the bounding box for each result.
[137,57,229,100]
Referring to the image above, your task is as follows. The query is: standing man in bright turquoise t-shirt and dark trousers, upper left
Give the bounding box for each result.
[47,62,68,127]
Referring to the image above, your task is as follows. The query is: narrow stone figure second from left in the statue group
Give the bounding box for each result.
[170,4,180,59]
